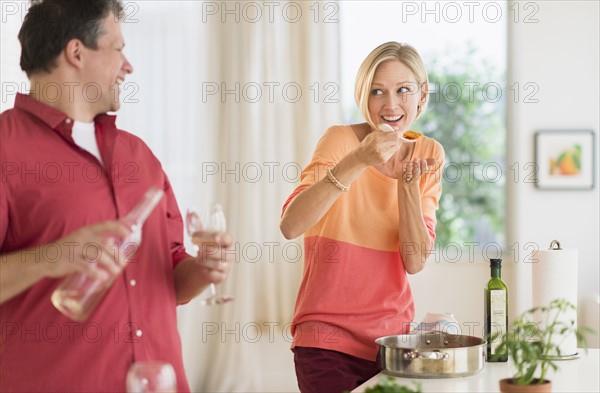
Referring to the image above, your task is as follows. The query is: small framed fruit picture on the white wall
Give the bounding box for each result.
[535,130,596,190]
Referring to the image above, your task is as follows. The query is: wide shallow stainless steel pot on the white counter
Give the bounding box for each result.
[375,332,485,378]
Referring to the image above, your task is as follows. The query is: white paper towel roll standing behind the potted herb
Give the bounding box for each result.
[531,242,577,356]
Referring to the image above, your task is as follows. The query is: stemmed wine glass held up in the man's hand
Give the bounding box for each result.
[186,203,233,306]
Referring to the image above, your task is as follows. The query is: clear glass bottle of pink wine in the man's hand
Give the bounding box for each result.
[51,188,164,322]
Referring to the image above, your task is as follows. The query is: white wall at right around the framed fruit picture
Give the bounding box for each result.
[507,1,600,340]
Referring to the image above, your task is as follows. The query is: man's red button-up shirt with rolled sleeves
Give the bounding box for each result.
[0,94,189,392]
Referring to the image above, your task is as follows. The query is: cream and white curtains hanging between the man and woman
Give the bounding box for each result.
[119,1,342,392]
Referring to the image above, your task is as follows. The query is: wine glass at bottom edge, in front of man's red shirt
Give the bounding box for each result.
[127,361,177,393]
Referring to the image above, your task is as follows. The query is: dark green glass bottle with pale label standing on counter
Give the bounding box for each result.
[484,259,508,362]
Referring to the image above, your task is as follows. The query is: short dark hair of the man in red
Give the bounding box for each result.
[19,0,123,77]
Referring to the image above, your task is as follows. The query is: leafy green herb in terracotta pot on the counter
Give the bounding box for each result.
[492,299,591,392]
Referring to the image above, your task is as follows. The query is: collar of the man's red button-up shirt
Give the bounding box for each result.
[15,93,117,138]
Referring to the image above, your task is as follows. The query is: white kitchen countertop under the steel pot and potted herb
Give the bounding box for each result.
[353,349,600,393]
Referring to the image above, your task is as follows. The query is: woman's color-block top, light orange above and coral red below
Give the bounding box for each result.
[283,126,444,361]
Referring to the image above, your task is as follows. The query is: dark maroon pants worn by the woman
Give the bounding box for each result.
[294,347,381,393]
